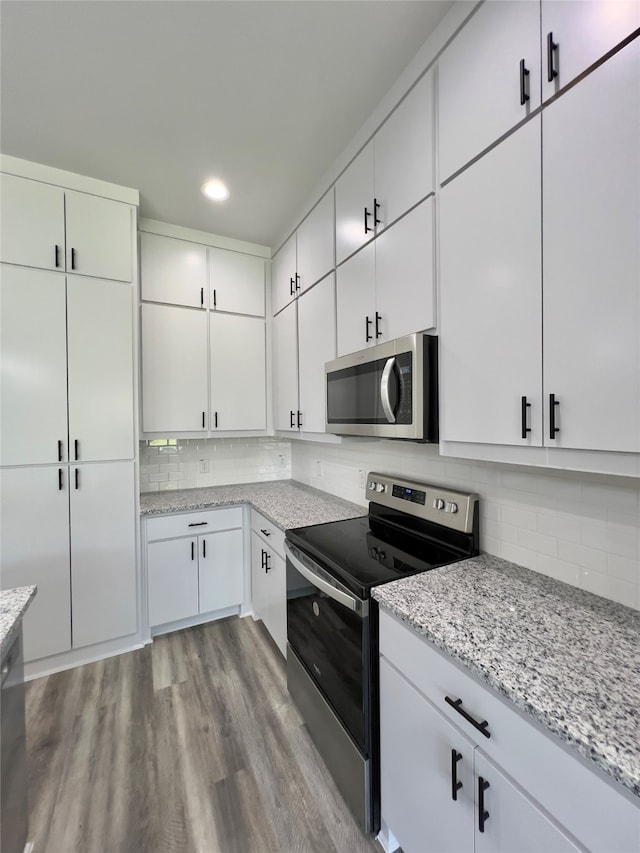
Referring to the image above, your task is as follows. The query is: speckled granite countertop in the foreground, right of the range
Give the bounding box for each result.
[373,555,640,797]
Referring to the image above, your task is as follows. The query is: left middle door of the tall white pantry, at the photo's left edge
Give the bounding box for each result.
[0,265,67,465]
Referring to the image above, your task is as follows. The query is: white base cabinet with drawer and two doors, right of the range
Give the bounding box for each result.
[380,611,640,853]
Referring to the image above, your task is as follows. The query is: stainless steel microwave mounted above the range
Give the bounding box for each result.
[325,334,438,442]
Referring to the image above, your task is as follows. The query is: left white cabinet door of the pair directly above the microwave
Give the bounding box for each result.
[336,243,376,356]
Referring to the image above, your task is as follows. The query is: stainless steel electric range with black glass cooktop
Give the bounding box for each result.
[285,473,479,833]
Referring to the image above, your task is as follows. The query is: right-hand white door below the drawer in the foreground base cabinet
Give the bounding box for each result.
[472,749,582,853]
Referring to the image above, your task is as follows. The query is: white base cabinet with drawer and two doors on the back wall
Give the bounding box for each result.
[146,506,245,634]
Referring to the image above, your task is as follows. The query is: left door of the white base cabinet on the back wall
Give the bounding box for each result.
[147,537,198,626]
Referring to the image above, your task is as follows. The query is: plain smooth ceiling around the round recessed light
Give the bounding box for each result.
[0,0,452,247]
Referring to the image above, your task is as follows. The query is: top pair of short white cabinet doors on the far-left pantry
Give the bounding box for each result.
[1,175,133,281]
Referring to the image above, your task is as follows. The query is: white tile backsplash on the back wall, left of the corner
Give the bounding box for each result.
[140,438,291,492]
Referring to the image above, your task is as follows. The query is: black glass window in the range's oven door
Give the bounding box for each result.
[287,561,369,753]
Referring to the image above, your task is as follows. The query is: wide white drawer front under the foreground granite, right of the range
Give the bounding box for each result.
[380,610,640,853]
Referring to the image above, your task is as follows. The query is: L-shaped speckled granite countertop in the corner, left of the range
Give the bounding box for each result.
[140,480,367,530]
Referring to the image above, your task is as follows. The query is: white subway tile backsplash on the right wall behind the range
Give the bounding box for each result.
[292,439,640,610]
